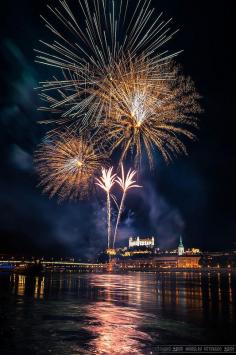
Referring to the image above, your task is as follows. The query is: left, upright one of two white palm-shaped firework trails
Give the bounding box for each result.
[96,167,116,249]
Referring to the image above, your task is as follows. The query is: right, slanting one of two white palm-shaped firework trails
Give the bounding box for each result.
[113,164,141,249]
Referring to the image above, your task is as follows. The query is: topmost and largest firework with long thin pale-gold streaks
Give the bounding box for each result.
[36,0,178,125]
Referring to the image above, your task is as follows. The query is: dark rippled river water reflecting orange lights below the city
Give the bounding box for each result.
[0,272,236,355]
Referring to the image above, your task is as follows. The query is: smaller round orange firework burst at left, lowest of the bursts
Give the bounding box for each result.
[35,131,104,200]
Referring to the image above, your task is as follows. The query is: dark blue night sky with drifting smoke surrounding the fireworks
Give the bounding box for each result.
[0,0,236,256]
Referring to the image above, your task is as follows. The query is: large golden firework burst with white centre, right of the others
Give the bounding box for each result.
[96,58,200,167]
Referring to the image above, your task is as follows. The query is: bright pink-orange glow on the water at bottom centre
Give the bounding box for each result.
[85,302,152,354]
